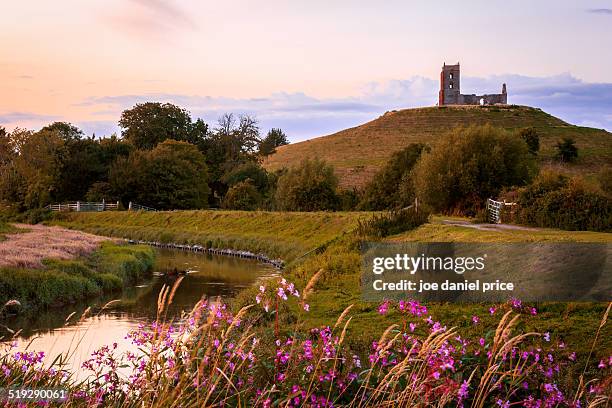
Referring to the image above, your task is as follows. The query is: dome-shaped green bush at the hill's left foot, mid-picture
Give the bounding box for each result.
[275,159,339,211]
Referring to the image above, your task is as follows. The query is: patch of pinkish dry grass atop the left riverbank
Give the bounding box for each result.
[0,224,110,268]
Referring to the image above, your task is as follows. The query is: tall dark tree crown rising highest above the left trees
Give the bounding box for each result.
[119,102,208,150]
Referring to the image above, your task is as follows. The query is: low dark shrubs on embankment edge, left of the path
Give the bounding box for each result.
[357,207,431,238]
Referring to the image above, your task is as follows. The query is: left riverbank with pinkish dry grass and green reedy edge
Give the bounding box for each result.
[0,225,155,313]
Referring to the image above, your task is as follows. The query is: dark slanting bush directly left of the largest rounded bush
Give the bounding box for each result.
[359,143,426,211]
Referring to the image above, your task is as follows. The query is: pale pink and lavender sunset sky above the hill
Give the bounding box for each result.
[0,0,612,142]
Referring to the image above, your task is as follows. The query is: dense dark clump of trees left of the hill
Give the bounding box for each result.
[0,102,289,211]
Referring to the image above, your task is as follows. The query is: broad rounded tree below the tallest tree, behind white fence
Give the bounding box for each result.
[109,140,210,209]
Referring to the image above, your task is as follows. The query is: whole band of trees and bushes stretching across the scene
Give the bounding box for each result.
[0,102,612,230]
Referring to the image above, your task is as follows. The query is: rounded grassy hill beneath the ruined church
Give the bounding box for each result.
[264,105,612,187]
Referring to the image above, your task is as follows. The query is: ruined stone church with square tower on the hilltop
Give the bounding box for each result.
[438,63,508,106]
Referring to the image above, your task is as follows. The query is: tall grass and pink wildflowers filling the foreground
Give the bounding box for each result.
[0,280,612,407]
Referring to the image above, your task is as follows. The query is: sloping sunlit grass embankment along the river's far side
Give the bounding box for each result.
[52,211,367,261]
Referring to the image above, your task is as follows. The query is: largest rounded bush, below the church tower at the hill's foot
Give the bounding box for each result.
[413,125,535,214]
